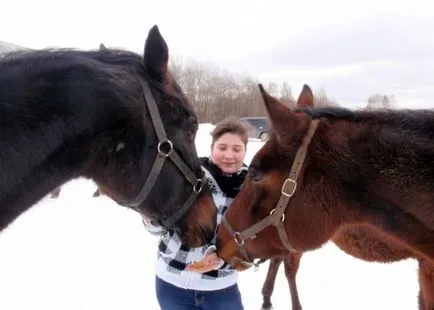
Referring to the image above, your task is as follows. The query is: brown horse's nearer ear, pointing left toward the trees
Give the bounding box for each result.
[258,84,292,138]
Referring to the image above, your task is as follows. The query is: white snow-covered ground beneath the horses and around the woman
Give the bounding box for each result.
[0,126,418,310]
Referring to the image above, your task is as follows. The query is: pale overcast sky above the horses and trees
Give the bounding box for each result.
[0,0,434,108]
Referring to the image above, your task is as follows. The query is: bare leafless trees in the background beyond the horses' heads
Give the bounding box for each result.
[170,57,395,123]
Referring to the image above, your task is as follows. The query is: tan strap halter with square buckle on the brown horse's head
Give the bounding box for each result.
[222,119,319,267]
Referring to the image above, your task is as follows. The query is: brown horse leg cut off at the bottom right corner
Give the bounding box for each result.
[419,259,434,310]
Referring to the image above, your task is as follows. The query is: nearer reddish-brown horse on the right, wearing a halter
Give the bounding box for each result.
[217,86,434,307]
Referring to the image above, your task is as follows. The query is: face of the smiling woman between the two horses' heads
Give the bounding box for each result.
[211,133,246,174]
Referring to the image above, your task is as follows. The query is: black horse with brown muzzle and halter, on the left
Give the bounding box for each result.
[0,26,215,246]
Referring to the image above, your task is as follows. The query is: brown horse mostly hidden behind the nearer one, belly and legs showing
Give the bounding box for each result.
[262,85,434,310]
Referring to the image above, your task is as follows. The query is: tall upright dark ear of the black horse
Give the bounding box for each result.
[144,25,169,81]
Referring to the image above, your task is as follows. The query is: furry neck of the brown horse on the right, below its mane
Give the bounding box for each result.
[314,118,434,259]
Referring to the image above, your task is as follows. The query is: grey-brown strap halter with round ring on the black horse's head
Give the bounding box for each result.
[122,82,205,227]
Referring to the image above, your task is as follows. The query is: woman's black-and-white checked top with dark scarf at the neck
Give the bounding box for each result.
[145,158,247,291]
